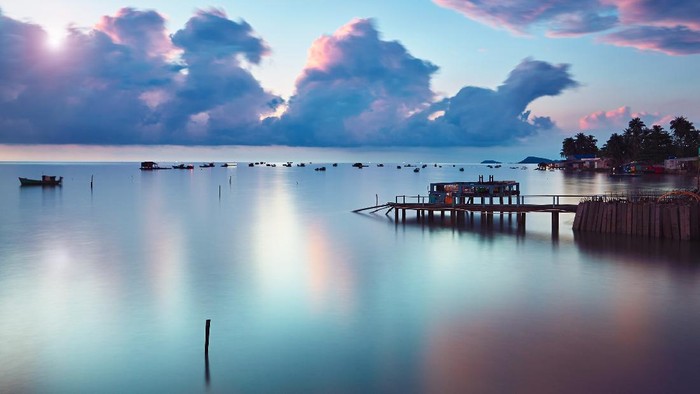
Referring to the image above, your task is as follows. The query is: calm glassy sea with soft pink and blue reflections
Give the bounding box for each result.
[0,162,700,393]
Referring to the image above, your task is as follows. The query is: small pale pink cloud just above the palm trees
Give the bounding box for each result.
[578,106,673,132]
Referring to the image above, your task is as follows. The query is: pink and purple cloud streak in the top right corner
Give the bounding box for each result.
[433,0,700,55]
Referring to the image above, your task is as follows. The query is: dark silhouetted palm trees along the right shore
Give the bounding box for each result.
[561,116,700,166]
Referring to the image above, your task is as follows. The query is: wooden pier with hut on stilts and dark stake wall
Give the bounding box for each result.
[353,177,700,240]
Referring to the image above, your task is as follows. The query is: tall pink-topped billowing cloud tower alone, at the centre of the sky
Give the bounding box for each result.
[277,19,438,145]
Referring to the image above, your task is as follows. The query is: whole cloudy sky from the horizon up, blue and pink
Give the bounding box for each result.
[0,0,700,160]
